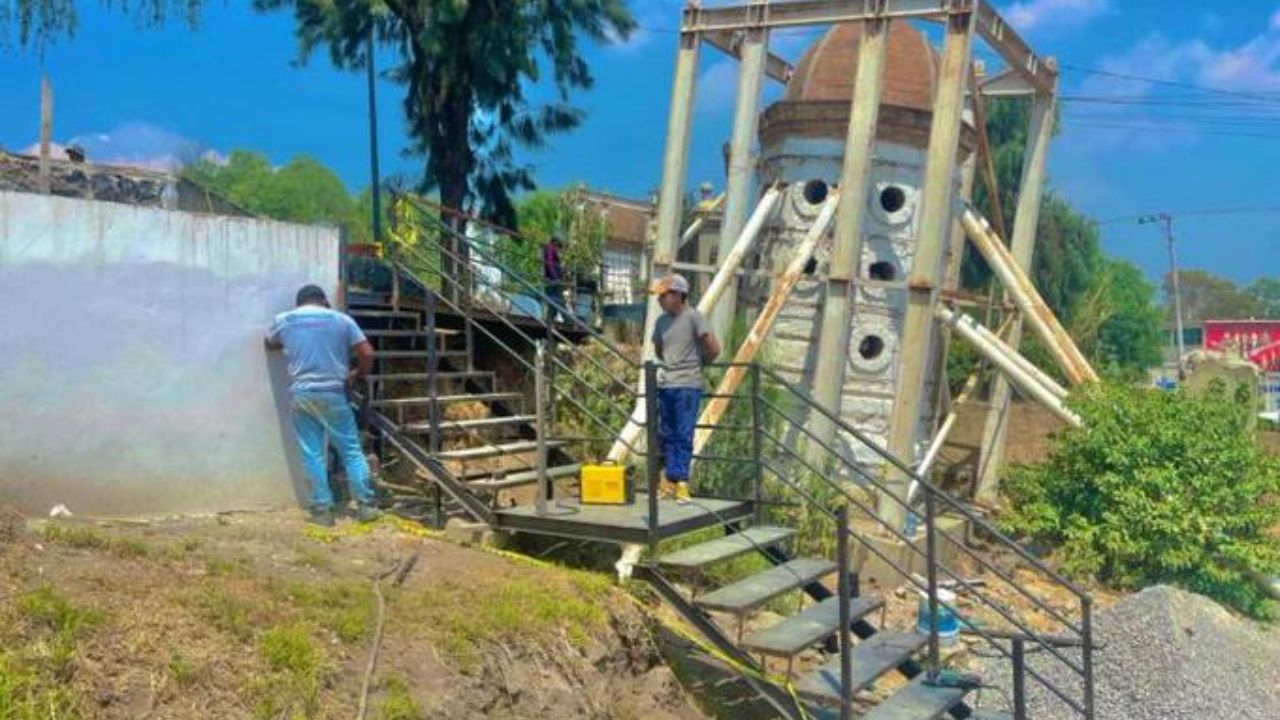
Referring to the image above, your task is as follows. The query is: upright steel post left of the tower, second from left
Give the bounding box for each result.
[710,28,769,340]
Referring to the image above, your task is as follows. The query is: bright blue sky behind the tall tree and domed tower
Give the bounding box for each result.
[0,0,1280,282]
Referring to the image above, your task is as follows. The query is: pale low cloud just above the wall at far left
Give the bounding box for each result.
[24,120,212,172]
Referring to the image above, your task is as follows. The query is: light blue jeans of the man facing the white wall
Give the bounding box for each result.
[293,391,374,510]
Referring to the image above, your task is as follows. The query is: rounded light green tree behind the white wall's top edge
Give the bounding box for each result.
[182,150,372,243]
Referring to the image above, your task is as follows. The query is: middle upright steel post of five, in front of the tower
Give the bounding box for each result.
[809,19,890,464]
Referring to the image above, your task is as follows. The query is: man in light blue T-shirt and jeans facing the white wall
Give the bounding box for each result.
[266,284,379,527]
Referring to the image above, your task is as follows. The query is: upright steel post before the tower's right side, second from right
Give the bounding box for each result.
[877,12,974,528]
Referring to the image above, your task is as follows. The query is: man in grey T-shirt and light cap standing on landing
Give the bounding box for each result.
[653,275,721,503]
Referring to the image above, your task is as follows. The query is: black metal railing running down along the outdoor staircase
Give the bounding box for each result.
[371,196,1094,720]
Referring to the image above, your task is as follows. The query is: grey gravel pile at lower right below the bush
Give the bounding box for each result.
[982,585,1280,720]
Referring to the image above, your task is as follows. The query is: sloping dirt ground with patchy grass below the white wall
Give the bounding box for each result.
[0,511,704,720]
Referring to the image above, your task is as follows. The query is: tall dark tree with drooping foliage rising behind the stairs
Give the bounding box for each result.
[255,0,635,224]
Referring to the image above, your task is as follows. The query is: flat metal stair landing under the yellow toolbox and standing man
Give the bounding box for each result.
[494,493,753,544]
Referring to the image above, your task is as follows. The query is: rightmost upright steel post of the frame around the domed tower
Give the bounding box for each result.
[974,91,1056,501]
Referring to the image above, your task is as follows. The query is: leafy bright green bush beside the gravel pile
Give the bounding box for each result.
[1005,384,1280,618]
